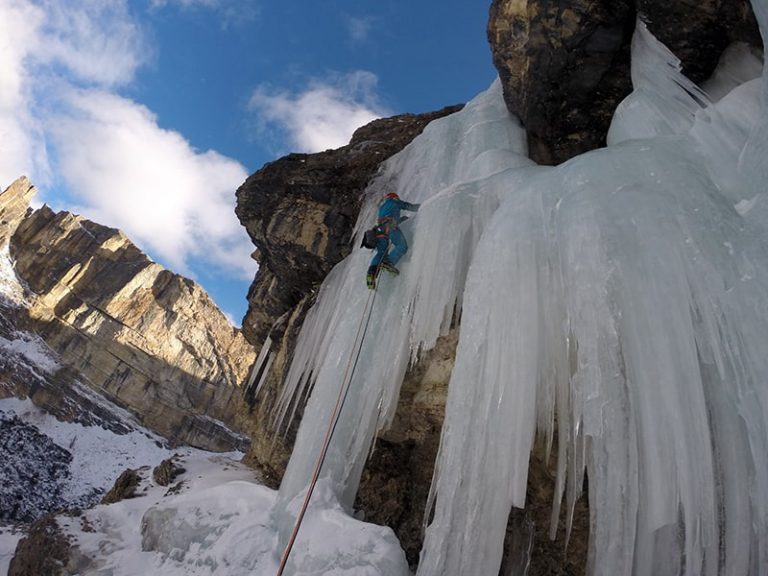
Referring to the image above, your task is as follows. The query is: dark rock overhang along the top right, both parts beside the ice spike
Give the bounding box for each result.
[488,0,762,164]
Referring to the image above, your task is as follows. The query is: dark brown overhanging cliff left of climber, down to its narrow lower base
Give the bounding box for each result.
[236,106,461,476]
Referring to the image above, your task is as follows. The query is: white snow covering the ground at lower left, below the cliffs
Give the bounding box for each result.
[0,398,409,576]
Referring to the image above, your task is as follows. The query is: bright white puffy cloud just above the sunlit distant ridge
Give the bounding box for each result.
[52,91,255,278]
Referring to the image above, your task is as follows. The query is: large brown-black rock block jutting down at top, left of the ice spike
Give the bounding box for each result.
[488,0,635,164]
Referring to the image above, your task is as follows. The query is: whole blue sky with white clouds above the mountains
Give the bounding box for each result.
[0,0,495,324]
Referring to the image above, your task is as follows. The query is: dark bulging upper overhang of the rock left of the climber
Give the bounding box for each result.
[236,106,461,346]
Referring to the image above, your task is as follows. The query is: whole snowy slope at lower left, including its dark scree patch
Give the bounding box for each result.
[0,246,408,576]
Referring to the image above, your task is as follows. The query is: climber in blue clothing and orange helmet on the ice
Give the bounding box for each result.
[366,192,420,289]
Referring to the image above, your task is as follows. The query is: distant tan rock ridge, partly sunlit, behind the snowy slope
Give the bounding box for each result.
[0,182,255,451]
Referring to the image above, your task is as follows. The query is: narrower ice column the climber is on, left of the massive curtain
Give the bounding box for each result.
[278,82,531,544]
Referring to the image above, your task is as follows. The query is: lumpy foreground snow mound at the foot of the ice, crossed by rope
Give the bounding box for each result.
[59,455,409,576]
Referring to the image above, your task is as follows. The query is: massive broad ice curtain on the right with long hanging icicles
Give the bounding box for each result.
[419,130,768,576]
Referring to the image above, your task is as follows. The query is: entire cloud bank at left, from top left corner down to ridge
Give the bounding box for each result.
[0,0,256,278]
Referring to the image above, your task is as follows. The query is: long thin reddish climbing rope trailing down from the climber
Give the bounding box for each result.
[277,290,377,576]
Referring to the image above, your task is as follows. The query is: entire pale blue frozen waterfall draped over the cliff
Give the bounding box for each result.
[270,2,768,576]
